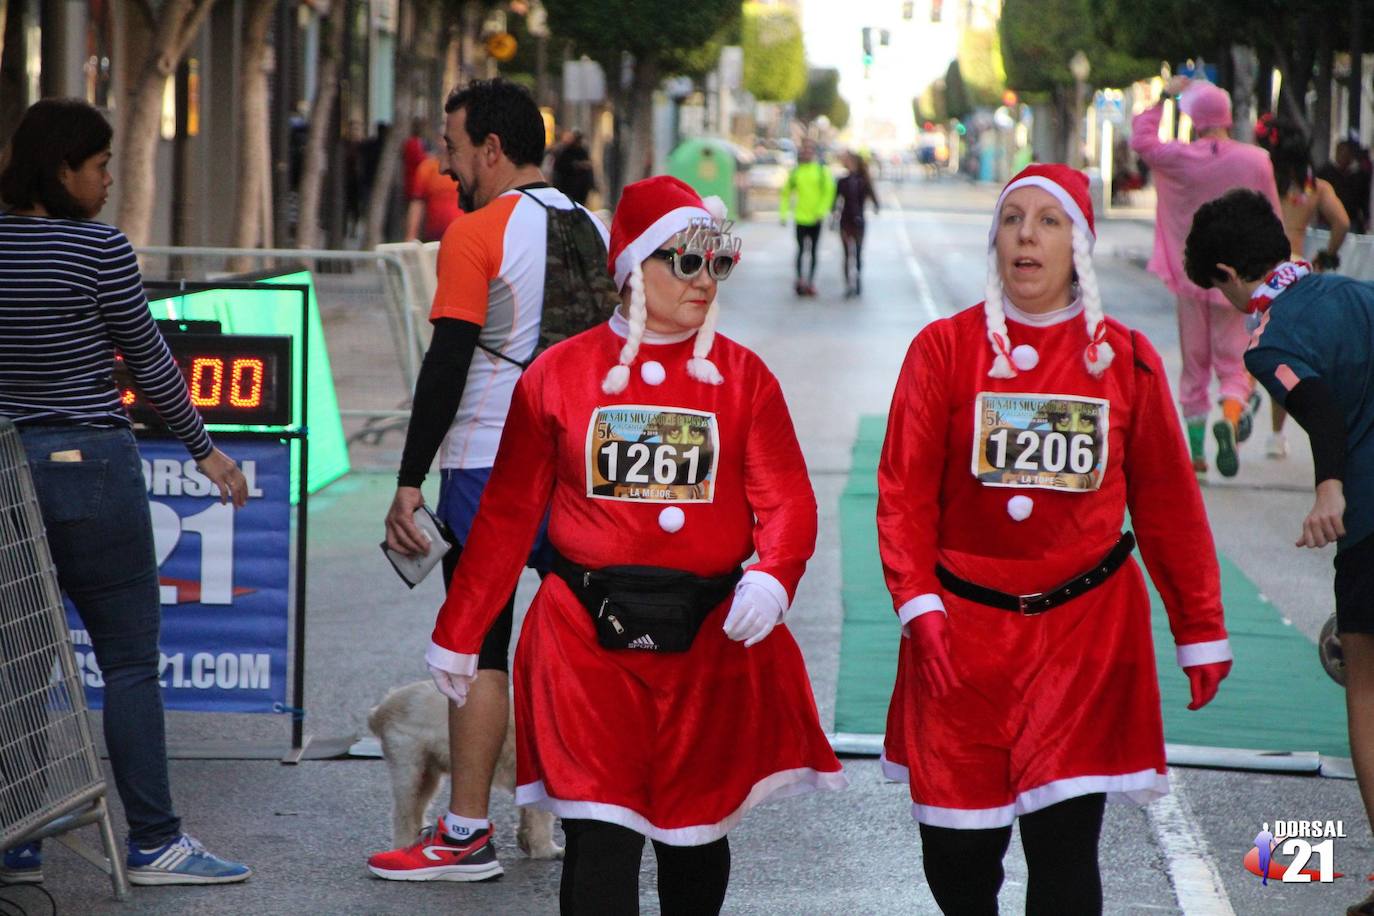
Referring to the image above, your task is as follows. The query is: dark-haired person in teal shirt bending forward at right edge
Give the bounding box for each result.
[1186,190,1374,916]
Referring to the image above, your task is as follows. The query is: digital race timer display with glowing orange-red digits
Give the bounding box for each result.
[114,334,291,426]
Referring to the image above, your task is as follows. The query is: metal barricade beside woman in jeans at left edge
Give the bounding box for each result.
[0,417,129,900]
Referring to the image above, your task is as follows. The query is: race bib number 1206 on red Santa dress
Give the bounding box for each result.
[973,391,1112,492]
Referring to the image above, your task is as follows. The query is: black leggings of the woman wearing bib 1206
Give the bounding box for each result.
[921,792,1106,916]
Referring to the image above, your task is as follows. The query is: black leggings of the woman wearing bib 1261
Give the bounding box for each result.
[558,817,730,916]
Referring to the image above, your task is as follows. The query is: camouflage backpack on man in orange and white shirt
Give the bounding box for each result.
[480,188,620,369]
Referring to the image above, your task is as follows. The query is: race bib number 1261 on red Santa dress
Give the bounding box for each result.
[587,404,720,503]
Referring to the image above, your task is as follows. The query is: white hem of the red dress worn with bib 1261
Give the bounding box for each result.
[515,766,849,846]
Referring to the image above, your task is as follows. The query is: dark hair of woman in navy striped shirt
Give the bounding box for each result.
[0,99,114,220]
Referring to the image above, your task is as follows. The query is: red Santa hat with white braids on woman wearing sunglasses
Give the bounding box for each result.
[602,174,725,394]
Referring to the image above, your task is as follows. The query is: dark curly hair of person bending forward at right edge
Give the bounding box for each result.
[1183,188,1289,290]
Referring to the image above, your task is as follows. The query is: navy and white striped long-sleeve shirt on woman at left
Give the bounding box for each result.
[0,213,213,460]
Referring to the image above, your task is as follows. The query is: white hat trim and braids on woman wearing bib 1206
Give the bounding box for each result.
[982,176,1116,379]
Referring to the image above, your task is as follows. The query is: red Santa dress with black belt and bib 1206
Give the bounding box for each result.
[878,302,1230,828]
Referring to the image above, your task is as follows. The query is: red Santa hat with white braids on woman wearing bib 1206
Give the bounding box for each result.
[982,163,1114,379]
